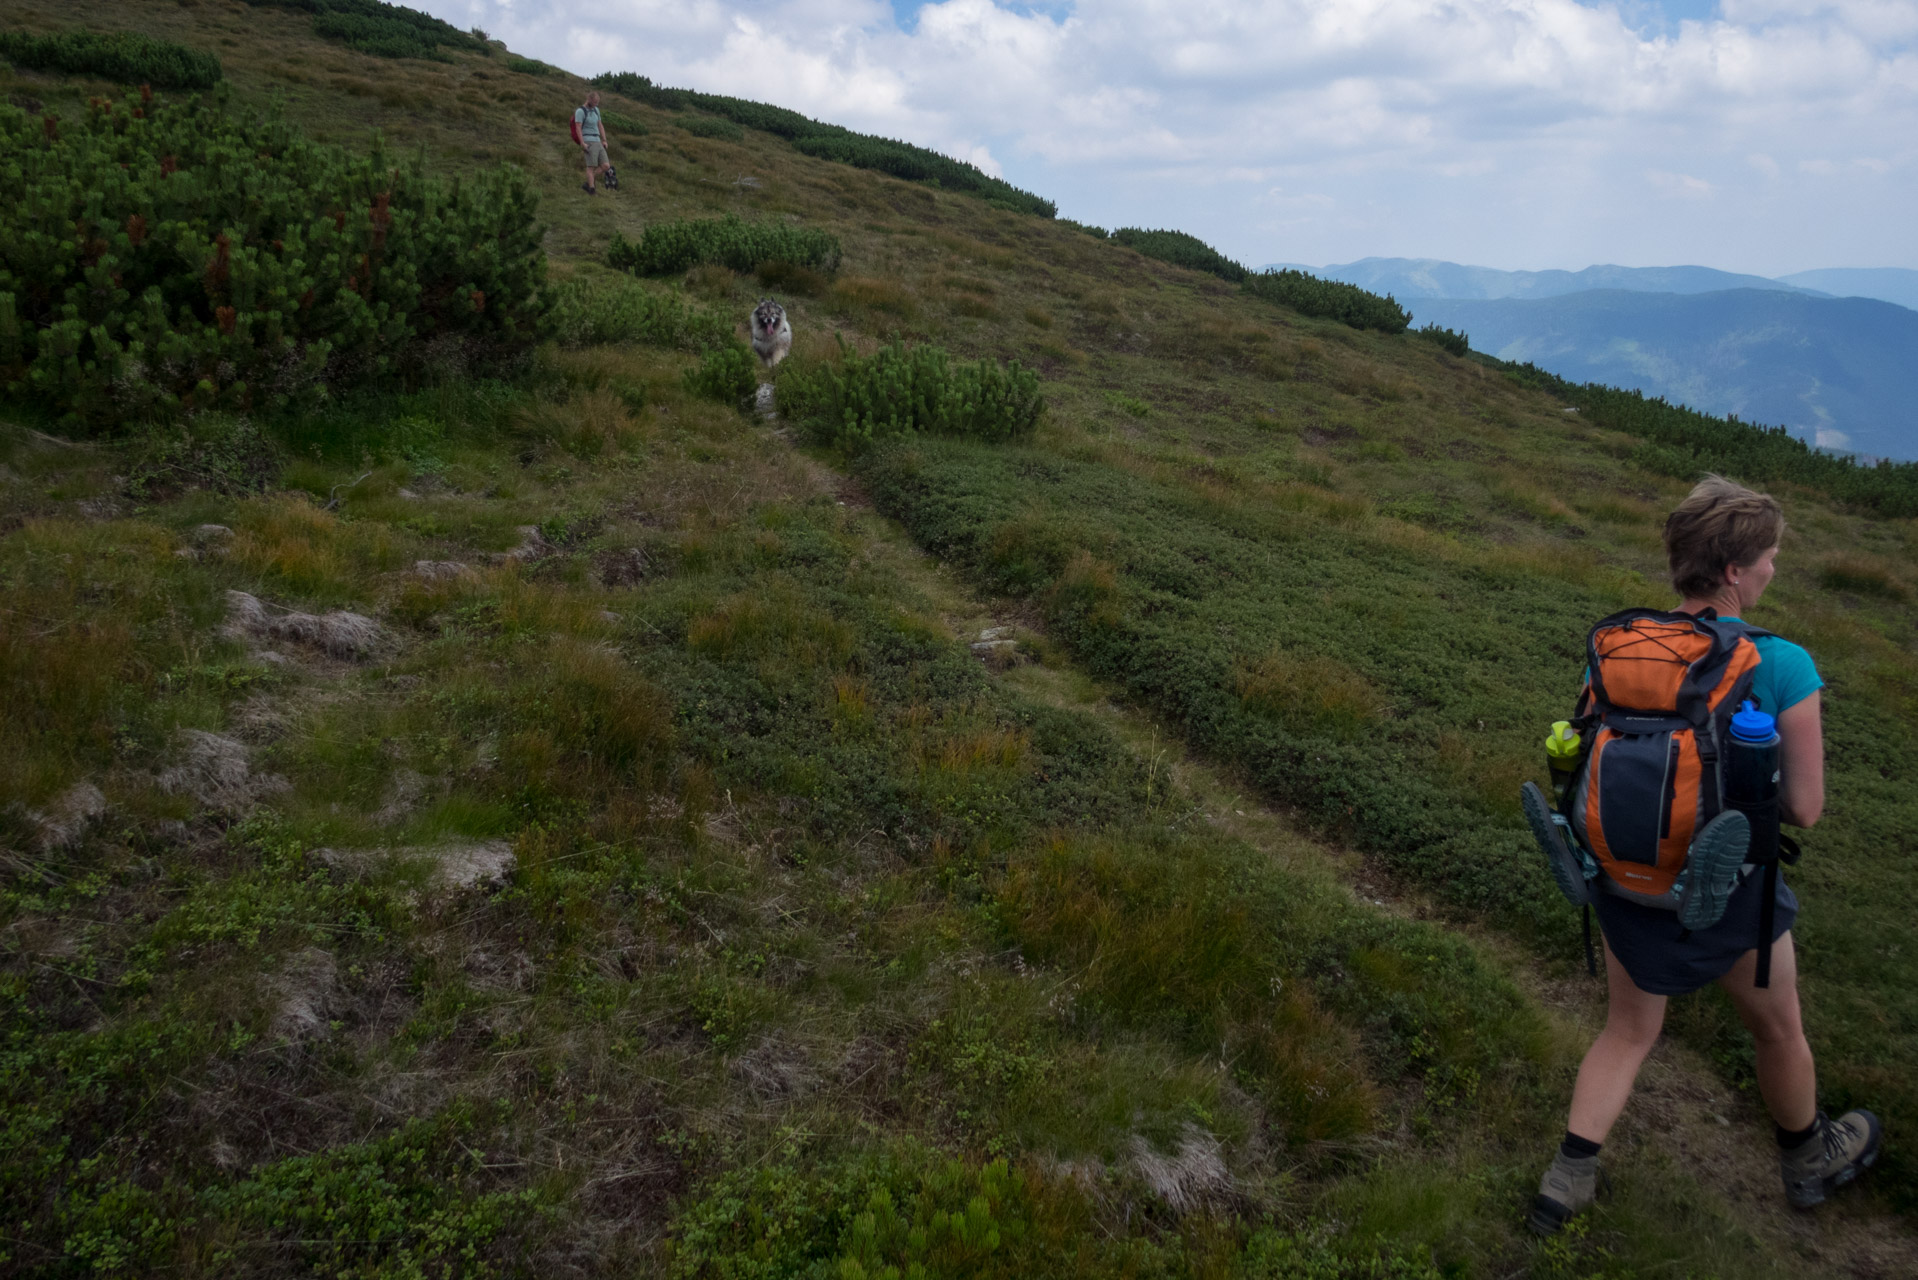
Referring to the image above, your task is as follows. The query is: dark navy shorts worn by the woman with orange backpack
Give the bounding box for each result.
[1592,871,1797,996]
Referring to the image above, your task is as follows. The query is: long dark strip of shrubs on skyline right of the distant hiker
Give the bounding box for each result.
[593,71,1059,217]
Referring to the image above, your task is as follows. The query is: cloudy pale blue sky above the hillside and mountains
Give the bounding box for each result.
[410,0,1918,276]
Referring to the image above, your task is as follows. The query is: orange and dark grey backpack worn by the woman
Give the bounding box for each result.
[1565,608,1770,910]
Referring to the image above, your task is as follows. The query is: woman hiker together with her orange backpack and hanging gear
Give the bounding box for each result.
[1523,476,1882,1236]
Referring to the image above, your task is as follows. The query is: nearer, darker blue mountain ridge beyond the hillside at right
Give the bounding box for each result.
[1406,288,1918,459]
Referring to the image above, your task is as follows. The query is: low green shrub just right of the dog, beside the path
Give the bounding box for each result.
[779,344,1045,449]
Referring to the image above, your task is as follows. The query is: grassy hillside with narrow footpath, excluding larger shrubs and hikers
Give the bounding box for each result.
[0,0,1918,1278]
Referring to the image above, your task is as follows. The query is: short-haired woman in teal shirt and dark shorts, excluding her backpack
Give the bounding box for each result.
[1529,476,1882,1236]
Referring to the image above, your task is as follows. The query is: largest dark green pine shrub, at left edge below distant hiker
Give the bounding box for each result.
[0,86,545,430]
